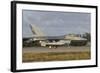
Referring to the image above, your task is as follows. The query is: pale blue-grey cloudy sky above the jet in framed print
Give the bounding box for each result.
[22,10,91,37]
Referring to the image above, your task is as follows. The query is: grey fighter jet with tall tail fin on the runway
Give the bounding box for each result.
[22,24,87,48]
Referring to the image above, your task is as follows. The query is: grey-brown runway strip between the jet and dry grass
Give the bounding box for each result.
[22,46,90,53]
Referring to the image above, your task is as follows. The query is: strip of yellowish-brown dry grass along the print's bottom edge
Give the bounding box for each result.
[22,52,91,62]
